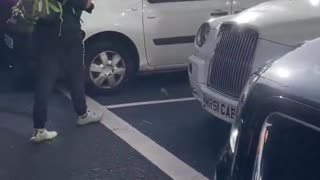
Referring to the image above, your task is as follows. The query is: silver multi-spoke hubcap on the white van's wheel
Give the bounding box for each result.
[90,51,126,89]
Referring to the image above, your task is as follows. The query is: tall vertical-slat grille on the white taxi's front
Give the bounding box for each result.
[208,24,259,98]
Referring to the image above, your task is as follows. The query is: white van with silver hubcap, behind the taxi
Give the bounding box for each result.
[82,0,259,92]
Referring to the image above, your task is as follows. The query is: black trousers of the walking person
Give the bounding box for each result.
[33,33,87,129]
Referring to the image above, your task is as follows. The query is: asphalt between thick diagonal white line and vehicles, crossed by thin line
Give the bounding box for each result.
[87,72,230,179]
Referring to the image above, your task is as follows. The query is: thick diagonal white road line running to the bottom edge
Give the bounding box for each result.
[61,90,209,180]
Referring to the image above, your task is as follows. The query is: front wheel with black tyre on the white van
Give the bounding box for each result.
[85,40,136,94]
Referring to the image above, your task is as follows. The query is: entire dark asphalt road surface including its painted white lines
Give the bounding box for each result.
[0,65,230,180]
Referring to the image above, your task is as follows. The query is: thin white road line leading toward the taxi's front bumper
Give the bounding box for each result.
[105,97,196,109]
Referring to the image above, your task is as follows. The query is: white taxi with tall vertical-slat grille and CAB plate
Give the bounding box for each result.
[189,0,320,122]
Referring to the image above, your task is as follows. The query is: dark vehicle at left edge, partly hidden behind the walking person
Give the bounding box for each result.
[0,0,40,80]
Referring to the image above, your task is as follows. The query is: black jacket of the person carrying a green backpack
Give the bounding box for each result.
[36,0,87,37]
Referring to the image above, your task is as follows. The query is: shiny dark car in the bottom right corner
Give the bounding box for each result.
[215,39,320,180]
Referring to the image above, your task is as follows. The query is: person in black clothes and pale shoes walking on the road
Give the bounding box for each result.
[31,0,102,142]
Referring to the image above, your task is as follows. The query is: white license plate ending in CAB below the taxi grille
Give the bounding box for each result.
[202,93,236,122]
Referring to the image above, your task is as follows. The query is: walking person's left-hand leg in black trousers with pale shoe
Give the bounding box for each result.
[31,52,60,142]
